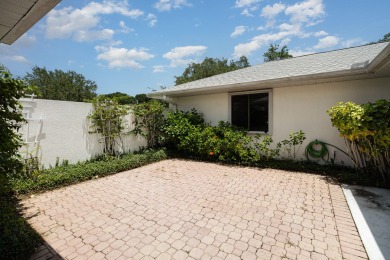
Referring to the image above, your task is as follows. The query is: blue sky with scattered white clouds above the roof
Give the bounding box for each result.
[0,0,390,95]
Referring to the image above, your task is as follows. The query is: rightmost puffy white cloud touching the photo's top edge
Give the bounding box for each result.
[285,0,325,25]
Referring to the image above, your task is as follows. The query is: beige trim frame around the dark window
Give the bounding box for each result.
[228,89,273,135]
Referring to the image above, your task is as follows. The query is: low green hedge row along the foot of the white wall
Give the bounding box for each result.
[10,150,167,194]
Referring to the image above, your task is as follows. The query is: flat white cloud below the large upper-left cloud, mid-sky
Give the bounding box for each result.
[95,46,154,69]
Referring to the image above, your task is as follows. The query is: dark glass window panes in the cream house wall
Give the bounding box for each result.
[232,93,269,133]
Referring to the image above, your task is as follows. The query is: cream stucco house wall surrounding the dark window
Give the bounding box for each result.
[177,78,390,165]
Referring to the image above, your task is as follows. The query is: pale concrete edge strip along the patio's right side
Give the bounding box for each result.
[341,185,385,260]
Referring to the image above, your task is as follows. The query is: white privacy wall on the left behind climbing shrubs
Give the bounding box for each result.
[21,99,146,167]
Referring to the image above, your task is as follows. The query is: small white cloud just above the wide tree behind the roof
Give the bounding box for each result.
[163,46,207,67]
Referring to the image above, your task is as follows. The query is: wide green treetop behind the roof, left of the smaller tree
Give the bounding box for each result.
[175,56,250,85]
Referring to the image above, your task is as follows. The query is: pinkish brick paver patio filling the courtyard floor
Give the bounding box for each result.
[23,160,367,259]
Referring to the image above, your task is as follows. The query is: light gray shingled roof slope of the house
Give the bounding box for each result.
[150,42,390,97]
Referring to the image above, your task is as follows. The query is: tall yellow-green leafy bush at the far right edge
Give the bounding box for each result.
[327,99,390,183]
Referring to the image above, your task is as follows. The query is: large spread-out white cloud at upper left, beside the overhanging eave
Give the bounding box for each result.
[45,0,143,42]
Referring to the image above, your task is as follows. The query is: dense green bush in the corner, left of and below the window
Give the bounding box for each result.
[163,109,255,162]
